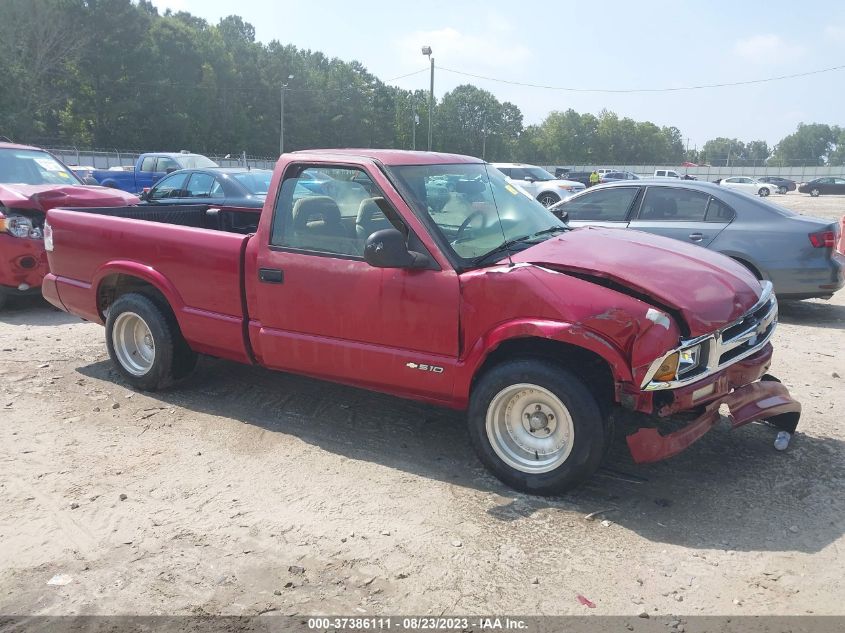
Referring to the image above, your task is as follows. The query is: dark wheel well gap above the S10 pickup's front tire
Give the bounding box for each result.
[472,337,616,413]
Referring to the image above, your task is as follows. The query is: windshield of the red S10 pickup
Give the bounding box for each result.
[390,164,567,266]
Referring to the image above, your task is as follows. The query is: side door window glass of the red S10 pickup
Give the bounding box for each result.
[270,166,406,257]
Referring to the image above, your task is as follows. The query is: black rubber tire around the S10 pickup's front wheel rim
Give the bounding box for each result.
[468,359,607,495]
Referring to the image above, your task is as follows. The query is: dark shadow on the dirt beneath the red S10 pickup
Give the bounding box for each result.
[78,358,845,552]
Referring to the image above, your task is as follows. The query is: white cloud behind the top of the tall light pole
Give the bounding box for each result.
[394,14,532,75]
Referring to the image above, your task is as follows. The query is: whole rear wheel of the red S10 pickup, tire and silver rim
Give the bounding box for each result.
[106,293,196,391]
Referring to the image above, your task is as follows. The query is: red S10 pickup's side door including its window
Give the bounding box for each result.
[246,164,459,399]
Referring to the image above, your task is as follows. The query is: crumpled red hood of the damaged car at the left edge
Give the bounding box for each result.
[0,183,140,212]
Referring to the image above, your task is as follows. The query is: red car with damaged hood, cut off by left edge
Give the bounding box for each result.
[0,143,138,308]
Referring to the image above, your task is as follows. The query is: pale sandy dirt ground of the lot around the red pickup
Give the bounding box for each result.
[0,194,845,615]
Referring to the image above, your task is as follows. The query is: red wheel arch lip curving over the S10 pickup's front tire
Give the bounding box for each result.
[454,319,633,401]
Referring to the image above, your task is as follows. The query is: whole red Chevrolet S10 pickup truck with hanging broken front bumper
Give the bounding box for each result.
[43,150,801,494]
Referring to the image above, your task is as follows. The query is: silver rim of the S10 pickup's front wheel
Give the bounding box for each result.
[486,383,575,474]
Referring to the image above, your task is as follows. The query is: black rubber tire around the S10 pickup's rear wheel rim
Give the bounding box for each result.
[106,293,196,391]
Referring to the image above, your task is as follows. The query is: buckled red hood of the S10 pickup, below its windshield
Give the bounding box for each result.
[512,227,762,336]
